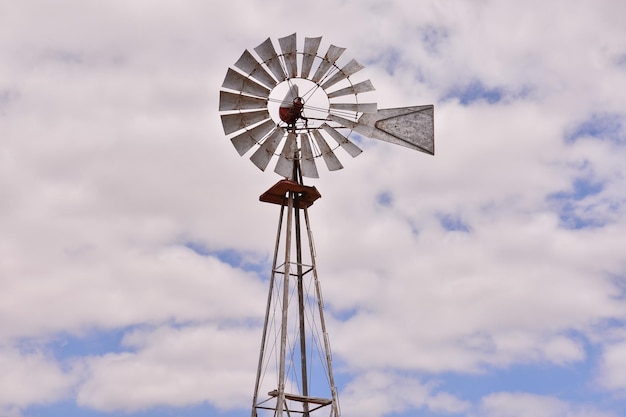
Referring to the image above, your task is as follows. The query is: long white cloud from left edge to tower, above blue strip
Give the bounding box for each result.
[0,244,265,338]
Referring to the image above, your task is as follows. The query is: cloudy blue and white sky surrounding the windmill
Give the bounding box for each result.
[0,0,626,417]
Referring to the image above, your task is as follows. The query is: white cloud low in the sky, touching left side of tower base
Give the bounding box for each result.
[75,324,259,412]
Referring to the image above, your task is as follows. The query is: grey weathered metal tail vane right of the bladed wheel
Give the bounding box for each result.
[352,105,435,155]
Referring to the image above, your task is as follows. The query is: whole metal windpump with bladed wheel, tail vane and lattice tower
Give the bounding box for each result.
[219,34,434,417]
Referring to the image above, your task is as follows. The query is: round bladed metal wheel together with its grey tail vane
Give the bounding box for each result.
[219,33,435,178]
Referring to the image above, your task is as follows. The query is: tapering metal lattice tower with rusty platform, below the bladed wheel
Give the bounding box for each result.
[252,180,339,417]
